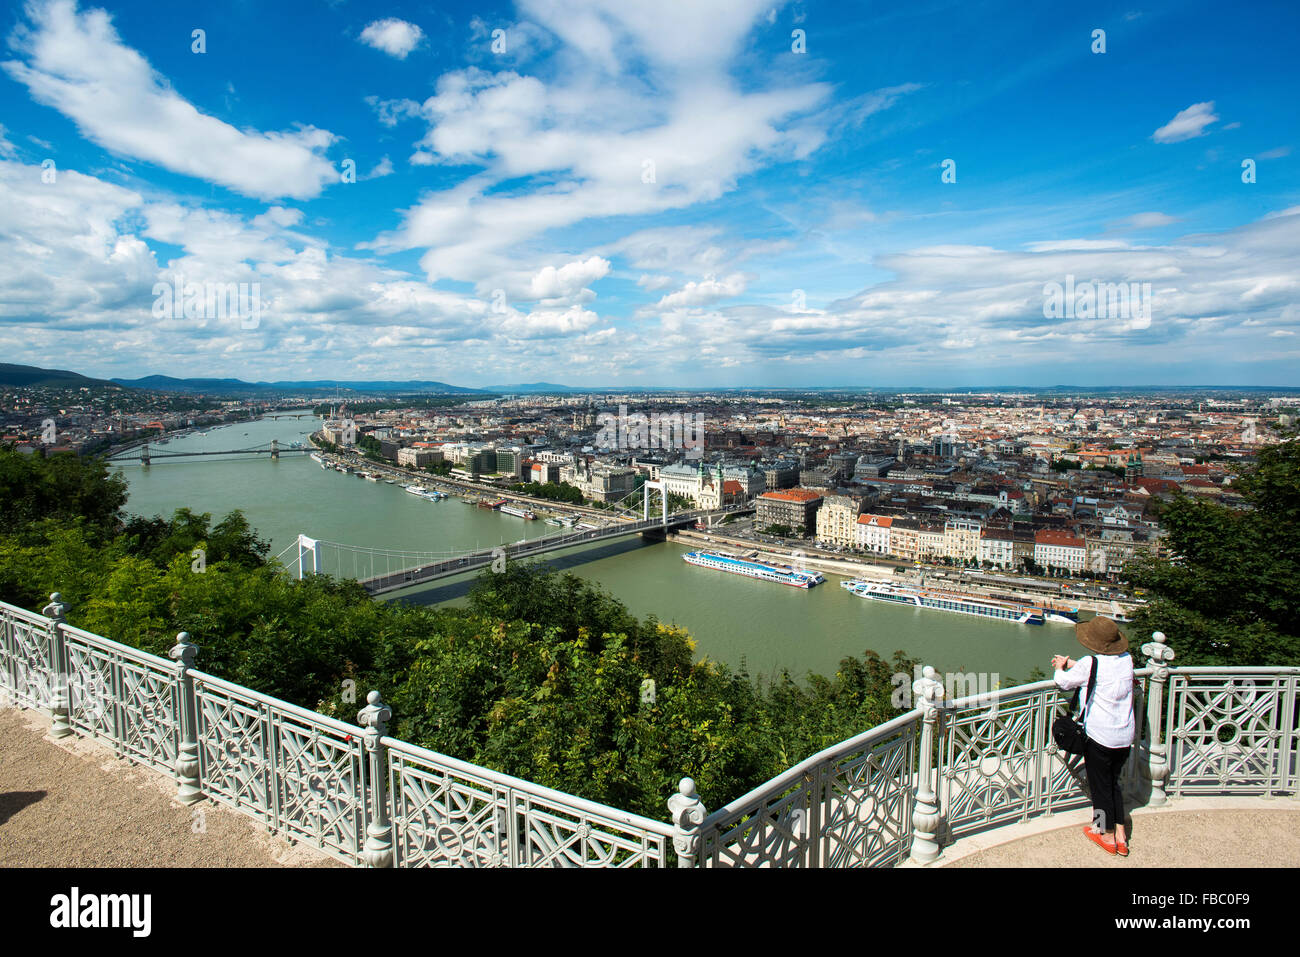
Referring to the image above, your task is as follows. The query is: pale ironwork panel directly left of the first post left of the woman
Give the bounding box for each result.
[818,724,917,867]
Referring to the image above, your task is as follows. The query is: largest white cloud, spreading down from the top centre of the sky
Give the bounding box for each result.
[365,0,831,283]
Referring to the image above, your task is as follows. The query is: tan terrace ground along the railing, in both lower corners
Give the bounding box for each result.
[0,707,1300,867]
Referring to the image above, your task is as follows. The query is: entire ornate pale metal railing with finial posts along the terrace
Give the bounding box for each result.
[0,594,1300,867]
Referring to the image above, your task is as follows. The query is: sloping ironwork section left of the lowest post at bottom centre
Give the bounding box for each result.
[389,742,667,867]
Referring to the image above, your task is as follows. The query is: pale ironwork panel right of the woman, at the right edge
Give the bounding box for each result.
[1167,671,1295,794]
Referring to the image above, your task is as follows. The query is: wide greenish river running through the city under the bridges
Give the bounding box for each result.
[121,419,1080,690]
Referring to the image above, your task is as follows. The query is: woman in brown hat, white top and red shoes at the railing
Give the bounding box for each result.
[1052,618,1134,857]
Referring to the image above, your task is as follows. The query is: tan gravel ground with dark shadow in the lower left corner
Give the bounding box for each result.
[0,707,343,867]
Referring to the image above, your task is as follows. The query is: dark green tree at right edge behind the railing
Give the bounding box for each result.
[1128,439,1300,666]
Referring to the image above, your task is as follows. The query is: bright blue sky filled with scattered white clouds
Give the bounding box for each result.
[0,0,1300,387]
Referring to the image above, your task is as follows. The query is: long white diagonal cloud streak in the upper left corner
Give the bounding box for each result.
[4,0,338,199]
